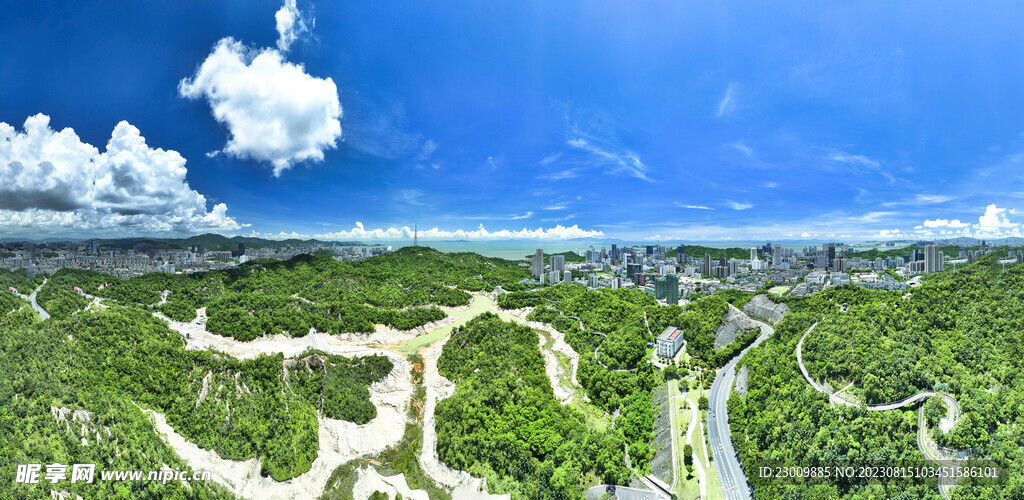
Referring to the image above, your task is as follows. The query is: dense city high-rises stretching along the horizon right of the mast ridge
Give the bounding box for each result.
[529,243,1024,304]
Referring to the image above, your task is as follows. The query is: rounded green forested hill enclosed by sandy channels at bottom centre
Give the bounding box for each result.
[436,314,634,499]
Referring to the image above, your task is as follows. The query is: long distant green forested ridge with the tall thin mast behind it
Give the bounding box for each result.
[39,247,528,340]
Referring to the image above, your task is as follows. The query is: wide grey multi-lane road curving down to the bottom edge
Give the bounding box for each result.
[708,321,775,500]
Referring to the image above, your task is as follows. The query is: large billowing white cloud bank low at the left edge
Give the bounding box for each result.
[0,114,243,235]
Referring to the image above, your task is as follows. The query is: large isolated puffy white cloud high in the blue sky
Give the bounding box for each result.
[178,38,342,176]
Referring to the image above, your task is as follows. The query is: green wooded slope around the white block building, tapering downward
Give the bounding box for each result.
[498,285,753,487]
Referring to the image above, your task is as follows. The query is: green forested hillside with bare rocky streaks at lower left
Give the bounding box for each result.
[0,307,392,498]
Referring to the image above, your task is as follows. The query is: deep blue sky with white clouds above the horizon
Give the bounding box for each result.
[0,0,1024,241]
